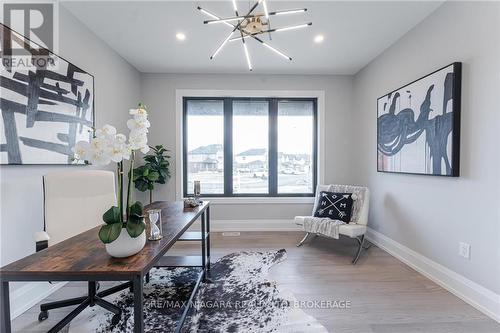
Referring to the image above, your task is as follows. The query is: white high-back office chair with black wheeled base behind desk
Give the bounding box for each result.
[35,170,125,332]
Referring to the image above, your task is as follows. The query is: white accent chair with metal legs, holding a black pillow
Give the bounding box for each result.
[295,185,370,264]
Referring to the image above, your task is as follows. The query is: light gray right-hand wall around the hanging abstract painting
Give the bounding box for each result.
[353,2,500,293]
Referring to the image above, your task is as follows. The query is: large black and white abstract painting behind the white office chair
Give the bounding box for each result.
[0,25,94,164]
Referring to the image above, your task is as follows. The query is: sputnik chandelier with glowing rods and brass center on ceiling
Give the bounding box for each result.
[198,0,312,71]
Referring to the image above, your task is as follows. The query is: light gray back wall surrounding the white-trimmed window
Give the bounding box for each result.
[142,74,352,220]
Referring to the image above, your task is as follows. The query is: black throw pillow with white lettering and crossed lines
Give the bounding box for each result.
[314,191,354,223]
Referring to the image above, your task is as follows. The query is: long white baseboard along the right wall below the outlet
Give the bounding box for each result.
[366,228,500,322]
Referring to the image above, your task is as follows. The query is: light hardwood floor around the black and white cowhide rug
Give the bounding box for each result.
[13,232,500,333]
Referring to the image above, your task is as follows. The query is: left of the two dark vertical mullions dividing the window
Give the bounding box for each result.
[224,98,233,196]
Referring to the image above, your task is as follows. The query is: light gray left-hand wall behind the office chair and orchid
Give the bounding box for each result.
[0,6,141,278]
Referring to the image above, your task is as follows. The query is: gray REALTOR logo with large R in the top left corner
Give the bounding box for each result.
[0,0,58,71]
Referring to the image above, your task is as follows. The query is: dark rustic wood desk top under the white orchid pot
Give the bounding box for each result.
[0,201,209,281]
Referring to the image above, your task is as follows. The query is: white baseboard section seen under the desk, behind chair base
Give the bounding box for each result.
[10,282,66,320]
